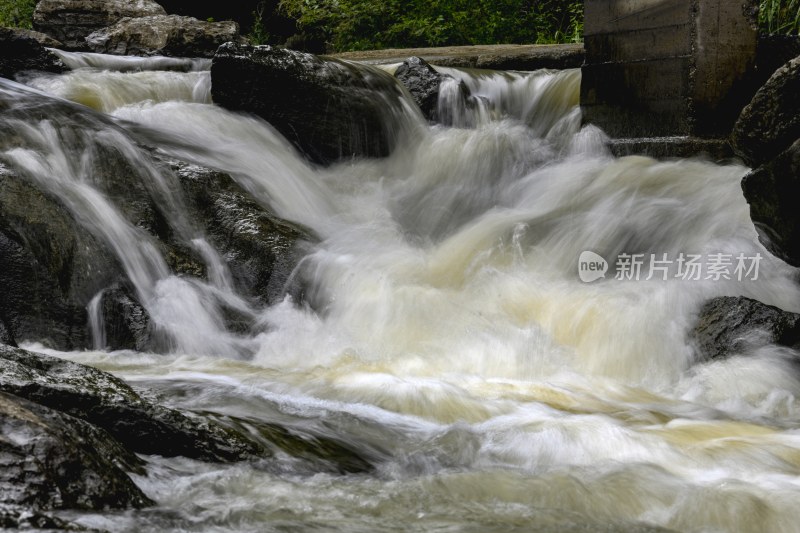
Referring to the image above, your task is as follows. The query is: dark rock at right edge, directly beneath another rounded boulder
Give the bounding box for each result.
[742,139,800,267]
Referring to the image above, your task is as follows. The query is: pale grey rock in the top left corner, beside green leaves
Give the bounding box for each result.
[33,0,167,50]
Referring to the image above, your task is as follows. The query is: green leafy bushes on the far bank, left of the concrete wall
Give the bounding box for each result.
[280,0,583,51]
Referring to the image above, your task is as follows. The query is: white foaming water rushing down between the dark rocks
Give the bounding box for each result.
[0,54,800,532]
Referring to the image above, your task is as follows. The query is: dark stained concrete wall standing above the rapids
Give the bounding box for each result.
[581,0,757,138]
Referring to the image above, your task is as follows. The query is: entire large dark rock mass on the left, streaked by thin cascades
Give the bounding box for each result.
[0,80,311,350]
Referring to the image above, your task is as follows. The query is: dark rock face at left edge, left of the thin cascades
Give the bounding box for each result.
[0,165,122,350]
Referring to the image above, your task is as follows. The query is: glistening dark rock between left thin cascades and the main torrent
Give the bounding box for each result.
[168,160,313,304]
